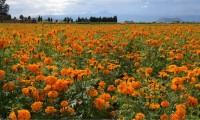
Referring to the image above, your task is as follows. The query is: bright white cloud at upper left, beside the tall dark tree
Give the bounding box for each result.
[7,0,79,16]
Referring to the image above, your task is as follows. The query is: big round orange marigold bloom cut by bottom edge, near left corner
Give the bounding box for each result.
[17,109,31,120]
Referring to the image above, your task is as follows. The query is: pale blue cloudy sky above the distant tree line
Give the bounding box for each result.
[6,0,200,21]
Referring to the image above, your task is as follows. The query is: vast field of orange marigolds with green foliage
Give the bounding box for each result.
[0,24,200,120]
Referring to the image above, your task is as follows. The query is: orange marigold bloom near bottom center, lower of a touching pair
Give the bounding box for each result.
[93,98,109,110]
